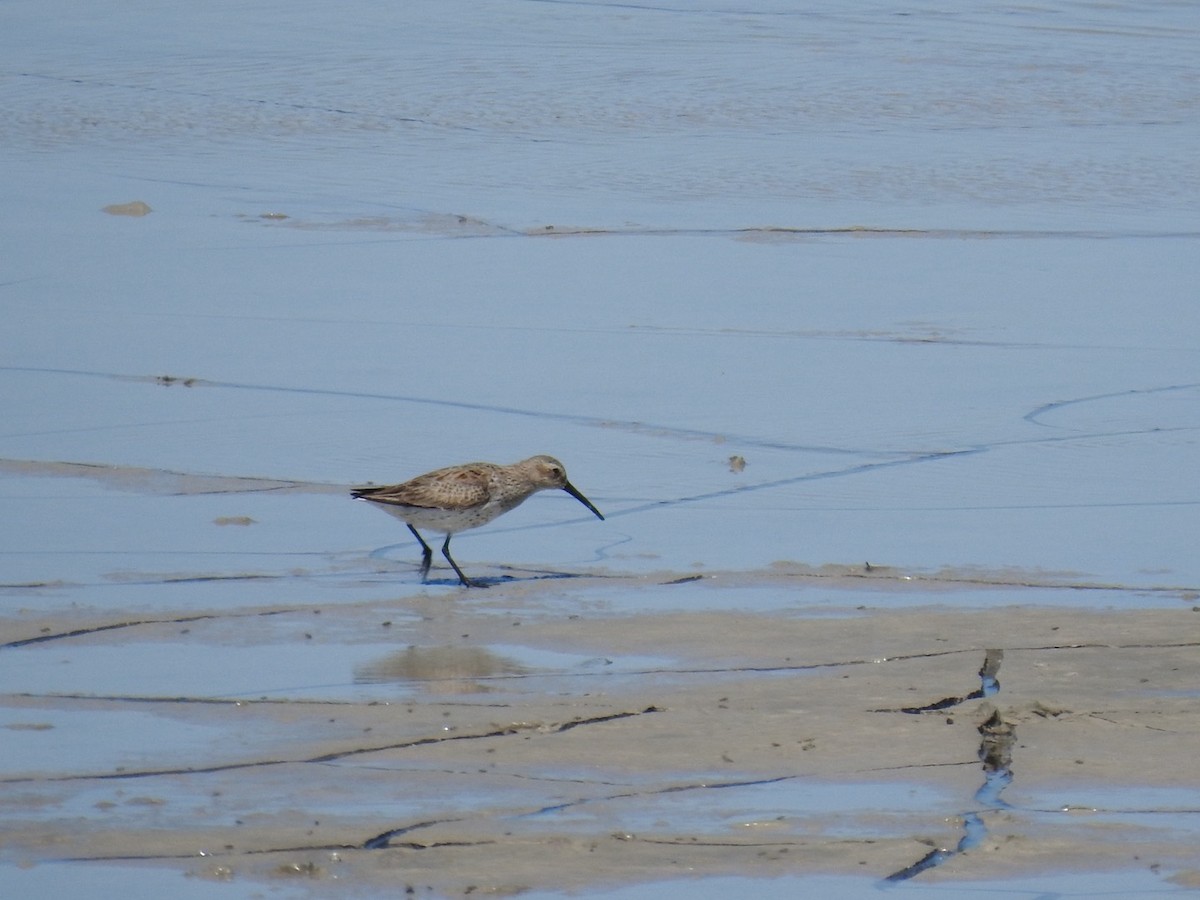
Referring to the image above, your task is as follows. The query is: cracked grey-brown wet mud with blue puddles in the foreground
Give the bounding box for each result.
[0,566,1200,895]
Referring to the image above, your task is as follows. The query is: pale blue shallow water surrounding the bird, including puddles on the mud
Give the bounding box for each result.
[0,0,1200,898]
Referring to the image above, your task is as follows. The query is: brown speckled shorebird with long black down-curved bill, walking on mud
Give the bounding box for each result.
[352,456,604,588]
